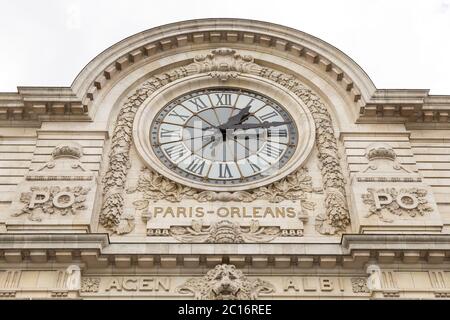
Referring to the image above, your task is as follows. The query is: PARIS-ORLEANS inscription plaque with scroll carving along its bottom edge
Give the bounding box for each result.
[144,201,308,243]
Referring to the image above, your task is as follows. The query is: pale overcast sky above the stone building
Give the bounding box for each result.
[0,0,450,95]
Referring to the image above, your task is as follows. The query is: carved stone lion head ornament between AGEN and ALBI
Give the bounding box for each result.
[176,264,275,300]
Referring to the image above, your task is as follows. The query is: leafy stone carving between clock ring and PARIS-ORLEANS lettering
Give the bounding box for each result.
[127,168,318,216]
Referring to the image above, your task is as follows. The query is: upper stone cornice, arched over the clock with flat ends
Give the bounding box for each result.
[0,19,450,127]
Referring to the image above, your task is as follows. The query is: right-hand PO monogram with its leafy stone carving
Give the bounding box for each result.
[361,188,433,223]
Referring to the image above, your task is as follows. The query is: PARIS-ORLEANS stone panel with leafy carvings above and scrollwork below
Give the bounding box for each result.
[128,169,317,243]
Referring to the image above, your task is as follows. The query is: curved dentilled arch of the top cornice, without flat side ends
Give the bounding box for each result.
[72,19,376,121]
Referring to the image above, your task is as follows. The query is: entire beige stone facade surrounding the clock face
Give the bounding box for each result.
[0,19,450,299]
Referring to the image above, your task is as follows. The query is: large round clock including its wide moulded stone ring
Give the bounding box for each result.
[133,74,315,192]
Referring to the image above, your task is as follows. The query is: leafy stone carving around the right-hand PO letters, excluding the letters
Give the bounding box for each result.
[361,188,433,223]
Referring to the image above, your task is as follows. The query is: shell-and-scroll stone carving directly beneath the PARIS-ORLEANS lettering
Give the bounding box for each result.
[169,220,281,243]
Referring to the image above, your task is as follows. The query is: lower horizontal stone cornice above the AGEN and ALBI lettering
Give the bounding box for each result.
[0,234,450,269]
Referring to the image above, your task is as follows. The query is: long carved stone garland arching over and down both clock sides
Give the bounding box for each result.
[100,48,350,234]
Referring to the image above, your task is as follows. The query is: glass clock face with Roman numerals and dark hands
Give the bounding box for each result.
[150,89,298,185]
